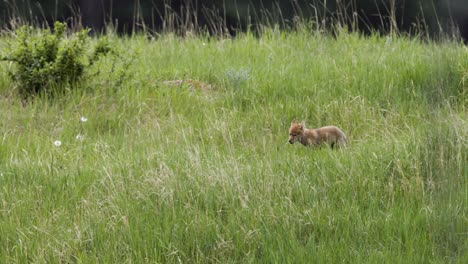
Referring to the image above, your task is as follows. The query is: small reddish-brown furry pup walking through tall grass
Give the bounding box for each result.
[289,119,346,149]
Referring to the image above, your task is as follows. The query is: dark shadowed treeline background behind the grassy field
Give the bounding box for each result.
[0,0,468,40]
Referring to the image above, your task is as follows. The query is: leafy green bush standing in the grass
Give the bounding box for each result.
[2,22,110,97]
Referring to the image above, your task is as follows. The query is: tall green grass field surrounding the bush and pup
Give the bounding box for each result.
[0,30,468,263]
